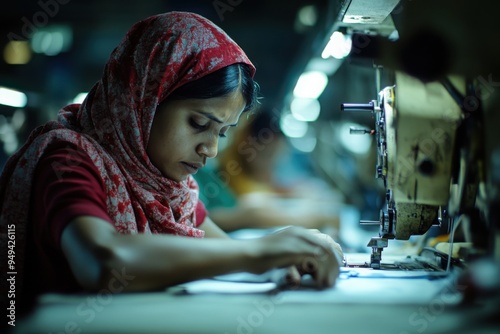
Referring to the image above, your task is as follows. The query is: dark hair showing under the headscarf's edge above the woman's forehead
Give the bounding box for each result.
[166,63,259,111]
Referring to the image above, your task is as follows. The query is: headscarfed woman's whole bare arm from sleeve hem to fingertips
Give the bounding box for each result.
[61,216,339,291]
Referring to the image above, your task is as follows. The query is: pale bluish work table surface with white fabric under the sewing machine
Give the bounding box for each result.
[7,254,500,334]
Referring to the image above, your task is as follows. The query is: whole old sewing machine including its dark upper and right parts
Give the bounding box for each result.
[341,1,500,269]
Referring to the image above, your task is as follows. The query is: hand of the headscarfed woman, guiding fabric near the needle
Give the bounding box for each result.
[253,227,343,288]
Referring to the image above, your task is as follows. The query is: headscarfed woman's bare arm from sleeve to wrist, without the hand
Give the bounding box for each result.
[62,217,256,291]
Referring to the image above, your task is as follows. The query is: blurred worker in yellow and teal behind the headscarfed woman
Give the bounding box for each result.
[195,108,342,236]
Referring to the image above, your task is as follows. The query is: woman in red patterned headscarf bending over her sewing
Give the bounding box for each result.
[0,12,339,314]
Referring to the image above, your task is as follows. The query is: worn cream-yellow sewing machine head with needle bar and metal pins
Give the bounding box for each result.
[341,72,465,268]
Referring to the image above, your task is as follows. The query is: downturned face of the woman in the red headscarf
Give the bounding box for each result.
[147,91,245,182]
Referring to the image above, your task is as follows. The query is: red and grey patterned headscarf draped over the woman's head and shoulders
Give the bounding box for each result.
[0,12,255,282]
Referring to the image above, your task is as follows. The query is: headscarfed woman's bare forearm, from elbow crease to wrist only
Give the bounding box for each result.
[107,234,256,290]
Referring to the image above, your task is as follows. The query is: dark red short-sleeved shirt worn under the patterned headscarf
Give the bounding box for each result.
[26,144,207,292]
